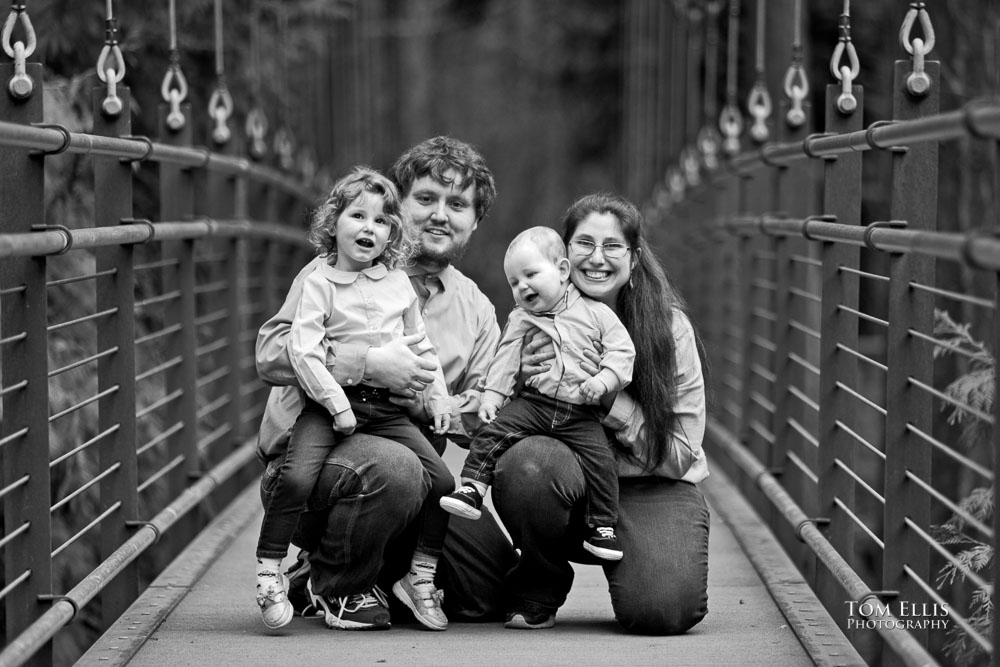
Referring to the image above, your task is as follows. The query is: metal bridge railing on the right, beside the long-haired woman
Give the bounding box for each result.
[651,72,1000,665]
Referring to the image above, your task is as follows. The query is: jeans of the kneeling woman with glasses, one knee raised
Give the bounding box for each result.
[493,436,709,635]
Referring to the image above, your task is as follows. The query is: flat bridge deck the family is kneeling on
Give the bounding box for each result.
[77,448,863,667]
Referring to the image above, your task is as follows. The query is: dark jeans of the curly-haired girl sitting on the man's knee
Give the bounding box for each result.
[257,390,455,558]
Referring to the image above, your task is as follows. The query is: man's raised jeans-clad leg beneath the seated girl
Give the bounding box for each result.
[261,434,431,597]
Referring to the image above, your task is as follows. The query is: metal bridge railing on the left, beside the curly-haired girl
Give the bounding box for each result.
[0,64,313,665]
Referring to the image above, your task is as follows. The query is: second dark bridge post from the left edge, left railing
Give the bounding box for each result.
[92,87,139,627]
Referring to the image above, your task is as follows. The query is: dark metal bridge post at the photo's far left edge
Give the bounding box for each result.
[0,63,52,665]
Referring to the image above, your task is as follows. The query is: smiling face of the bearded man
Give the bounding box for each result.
[403,171,479,269]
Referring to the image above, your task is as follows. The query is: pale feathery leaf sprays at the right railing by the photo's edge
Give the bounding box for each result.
[933,309,995,665]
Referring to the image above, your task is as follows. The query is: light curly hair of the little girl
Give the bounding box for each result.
[309,166,414,269]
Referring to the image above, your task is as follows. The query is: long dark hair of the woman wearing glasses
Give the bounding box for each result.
[562,192,704,470]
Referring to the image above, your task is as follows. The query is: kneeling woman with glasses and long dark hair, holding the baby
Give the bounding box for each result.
[493,193,709,635]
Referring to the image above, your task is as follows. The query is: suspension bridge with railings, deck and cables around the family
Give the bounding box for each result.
[0,0,1000,665]
